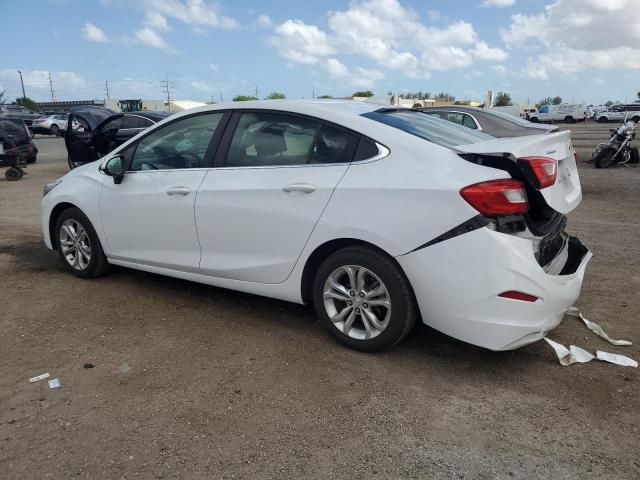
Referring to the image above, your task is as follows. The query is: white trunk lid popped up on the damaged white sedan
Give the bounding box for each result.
[456,131,582,214]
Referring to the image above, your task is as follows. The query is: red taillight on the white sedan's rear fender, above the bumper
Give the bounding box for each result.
[460,179,529,217]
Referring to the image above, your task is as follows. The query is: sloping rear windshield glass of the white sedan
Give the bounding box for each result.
[362,109,493,147]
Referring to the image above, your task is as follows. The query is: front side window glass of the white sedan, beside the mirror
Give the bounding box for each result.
[129,113,224,171]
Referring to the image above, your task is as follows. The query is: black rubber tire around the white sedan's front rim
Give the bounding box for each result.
[54,207,109,278]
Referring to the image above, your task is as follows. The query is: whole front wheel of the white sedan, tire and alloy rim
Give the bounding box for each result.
[54,207,109,278]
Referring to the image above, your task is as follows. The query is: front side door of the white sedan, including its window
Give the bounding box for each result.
[100,113,224,272]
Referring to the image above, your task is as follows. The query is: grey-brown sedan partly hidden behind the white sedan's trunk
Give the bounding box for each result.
[421,105,558,138]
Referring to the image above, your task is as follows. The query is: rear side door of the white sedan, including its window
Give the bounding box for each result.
[196,111,358,283]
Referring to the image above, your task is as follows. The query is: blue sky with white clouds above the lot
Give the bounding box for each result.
[0,0,640,104]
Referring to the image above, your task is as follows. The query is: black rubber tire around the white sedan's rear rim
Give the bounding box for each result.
[313,246,418,352]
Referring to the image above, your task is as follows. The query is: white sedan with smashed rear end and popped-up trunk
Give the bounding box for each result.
[42,101,591,351]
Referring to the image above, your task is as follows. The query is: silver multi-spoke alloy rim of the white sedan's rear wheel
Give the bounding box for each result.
[322,265,391,340]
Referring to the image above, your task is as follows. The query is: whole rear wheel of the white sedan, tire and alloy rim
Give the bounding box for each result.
[313,246,418,352]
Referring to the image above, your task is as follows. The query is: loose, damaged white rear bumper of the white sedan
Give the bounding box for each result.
[396,228,592,350]
